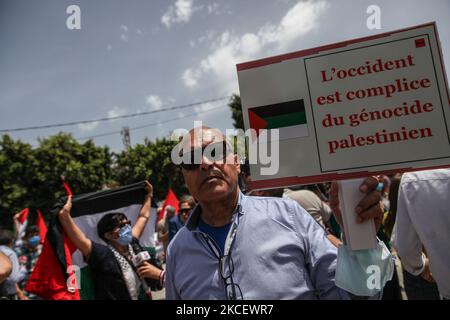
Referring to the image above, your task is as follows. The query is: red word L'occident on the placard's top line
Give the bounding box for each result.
[320,54,415,82]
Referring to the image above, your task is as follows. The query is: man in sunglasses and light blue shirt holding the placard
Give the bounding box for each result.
[166,127,394,299]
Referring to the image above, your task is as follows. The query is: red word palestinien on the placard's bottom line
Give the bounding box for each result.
[328,127,433,154]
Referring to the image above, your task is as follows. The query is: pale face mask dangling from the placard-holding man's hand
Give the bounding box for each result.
[335,241,395,297]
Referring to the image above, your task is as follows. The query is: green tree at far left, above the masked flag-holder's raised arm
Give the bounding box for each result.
[0,133,111,227]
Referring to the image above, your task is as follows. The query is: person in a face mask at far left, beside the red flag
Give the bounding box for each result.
[15,226,42,300]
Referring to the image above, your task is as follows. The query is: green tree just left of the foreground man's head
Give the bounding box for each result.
[113,138,187,201]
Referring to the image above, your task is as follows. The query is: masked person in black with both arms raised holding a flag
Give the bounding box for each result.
[58,182,162,300]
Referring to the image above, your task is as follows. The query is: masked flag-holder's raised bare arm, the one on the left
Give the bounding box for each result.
[58,196,92,258]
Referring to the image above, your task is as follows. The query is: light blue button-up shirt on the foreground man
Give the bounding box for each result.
[166,194,350,300]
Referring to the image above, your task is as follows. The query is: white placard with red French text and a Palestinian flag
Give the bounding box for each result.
[237,23,450,189]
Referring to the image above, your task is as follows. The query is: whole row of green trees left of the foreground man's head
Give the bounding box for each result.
[0,133,188,228]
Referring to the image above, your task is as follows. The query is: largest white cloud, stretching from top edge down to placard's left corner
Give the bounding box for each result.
[181,0,329,93]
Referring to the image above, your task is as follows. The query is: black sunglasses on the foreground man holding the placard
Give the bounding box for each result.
[180,141,231,171]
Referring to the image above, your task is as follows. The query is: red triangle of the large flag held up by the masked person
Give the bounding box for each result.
[25,234,80,300]
